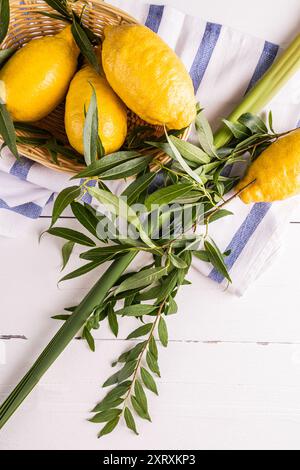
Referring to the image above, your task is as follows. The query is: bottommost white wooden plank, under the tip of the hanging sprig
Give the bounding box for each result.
[0,341,300,450]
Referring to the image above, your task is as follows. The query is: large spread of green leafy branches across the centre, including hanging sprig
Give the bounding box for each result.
[49,96,288,437]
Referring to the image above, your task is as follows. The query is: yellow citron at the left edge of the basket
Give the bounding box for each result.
[0,26,79,122]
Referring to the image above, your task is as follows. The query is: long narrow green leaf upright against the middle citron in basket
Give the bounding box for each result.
[83,85,99,165]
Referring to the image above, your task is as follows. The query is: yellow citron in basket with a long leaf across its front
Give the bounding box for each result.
[65,65,127,155]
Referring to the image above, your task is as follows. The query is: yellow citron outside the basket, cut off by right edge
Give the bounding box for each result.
[237,129,300,204]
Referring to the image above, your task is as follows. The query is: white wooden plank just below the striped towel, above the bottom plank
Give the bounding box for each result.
[0,220,300,346]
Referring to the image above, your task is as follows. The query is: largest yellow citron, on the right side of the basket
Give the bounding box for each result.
[102,25,196,129]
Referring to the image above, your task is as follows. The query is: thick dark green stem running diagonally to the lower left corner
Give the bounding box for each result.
[0,253,136,429]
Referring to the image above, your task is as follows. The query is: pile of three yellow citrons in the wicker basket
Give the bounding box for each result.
[0,25,196,158]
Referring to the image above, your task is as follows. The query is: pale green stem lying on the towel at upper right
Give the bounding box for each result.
[215,34,300,148]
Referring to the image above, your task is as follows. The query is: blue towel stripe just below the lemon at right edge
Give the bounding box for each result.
[209,203,272,284]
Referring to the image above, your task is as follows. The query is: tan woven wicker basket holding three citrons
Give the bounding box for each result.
[1,0,188,172]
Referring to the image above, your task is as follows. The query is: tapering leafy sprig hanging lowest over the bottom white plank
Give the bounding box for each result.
[90,260,188,437]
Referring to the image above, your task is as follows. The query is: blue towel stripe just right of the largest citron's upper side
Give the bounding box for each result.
[190,23,222,92]
